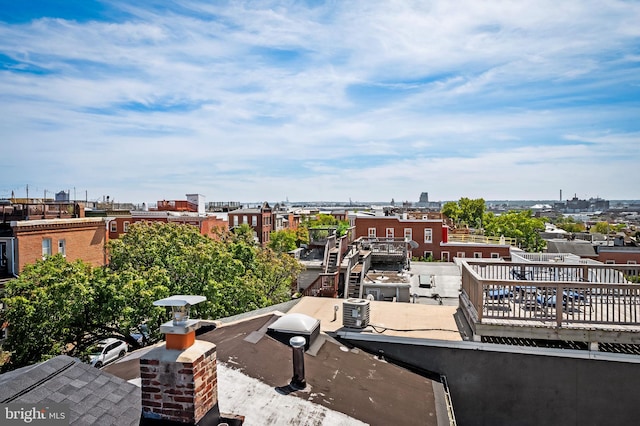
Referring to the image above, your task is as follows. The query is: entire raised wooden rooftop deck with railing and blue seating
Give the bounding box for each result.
[460,261,640,344]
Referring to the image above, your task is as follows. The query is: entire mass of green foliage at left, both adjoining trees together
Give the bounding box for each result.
[2,223,302,369]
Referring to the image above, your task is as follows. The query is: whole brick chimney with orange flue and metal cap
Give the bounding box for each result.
[140,296,218,424]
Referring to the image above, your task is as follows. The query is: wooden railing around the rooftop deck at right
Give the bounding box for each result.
[462,262,640,331]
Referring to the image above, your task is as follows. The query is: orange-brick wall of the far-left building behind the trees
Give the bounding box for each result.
[16,222,106,271]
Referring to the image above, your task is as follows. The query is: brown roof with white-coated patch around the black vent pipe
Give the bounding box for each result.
[104,312,449,425]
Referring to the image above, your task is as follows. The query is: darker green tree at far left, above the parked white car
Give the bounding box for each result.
[2,255,164,368]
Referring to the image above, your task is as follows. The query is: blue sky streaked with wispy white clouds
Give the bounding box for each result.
[0,0,640,203]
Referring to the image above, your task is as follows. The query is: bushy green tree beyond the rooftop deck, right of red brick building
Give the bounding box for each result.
[484,210,546,252]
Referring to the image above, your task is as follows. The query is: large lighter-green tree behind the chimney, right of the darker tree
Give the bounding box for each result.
[109,223,302,319]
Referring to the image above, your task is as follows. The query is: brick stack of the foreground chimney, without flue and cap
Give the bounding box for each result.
[140,346,218,424]
